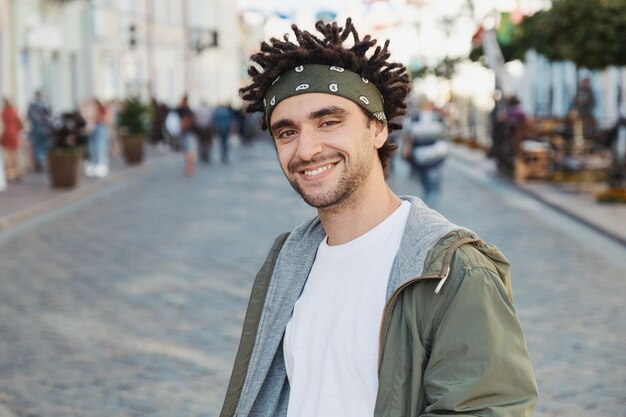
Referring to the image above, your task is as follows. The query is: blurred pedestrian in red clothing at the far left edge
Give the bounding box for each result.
[0,98,24,182]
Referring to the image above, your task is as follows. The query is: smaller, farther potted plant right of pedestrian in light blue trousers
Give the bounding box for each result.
[118,98,148,164]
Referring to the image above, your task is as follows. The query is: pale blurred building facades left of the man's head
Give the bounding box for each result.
[0,0,240,112]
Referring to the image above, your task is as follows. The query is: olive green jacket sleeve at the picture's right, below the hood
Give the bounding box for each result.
[423,266,537,417]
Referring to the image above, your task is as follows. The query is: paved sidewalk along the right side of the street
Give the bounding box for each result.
[450,144,626,246]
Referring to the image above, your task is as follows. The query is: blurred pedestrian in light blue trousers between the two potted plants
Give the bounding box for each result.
[85,98,110,178]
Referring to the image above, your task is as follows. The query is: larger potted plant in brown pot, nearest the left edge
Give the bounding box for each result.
[48,112,87,187]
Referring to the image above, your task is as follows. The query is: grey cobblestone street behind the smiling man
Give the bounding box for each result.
[0,142,626,417]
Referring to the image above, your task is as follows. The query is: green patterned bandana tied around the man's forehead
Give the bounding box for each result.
[263,64,387,126]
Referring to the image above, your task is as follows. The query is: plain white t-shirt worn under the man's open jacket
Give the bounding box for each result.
[283,202,411,417]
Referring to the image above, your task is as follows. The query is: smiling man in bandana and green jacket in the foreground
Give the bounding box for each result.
[221,19,537,417]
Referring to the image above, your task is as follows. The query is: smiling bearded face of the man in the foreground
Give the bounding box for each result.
[270,93,387,208]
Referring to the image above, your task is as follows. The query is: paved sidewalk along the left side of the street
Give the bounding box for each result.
[0,146,182,232]
